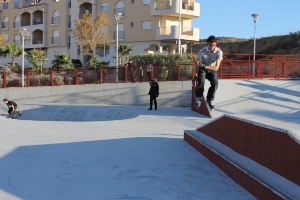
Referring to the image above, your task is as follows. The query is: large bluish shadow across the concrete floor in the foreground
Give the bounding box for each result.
[0,137,253,200]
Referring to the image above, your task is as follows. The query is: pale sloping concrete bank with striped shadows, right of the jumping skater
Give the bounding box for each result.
[197,79,300,124]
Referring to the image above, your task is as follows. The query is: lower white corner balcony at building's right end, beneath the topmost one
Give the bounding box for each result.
[156,26,199,41]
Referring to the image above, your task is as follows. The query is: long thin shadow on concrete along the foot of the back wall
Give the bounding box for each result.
[1,104,205,122]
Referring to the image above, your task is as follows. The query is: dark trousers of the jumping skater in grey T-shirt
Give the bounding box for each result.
[195,69,219,101]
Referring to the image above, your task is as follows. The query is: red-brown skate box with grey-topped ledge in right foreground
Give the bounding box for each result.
[184,115,300,199]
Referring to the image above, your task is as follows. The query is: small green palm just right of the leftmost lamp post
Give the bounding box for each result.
[26,49,48,74]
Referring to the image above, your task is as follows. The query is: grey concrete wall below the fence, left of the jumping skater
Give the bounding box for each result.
[0,81,191,106]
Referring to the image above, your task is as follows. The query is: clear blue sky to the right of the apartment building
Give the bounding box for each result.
[192,0,300,39]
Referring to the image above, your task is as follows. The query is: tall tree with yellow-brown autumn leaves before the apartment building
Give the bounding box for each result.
[71,13,111,59]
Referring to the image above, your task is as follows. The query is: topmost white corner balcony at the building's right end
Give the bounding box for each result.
[151,0,200,18]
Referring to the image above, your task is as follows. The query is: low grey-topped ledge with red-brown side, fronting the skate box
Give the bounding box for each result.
[184,130,300,199]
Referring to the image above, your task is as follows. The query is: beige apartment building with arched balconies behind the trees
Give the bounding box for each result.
[0,0,200,66]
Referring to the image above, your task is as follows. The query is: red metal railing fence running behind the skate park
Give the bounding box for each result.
[0,54,300,88]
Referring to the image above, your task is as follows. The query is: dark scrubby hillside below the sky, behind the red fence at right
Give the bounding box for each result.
[187,32,300,57]
